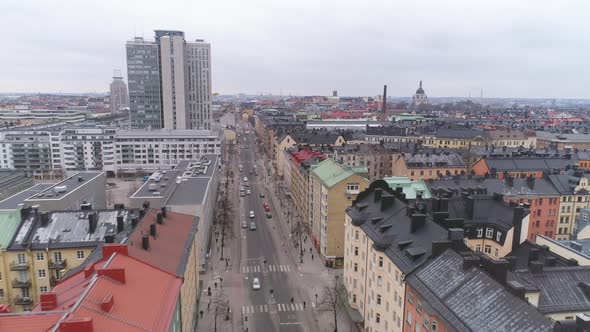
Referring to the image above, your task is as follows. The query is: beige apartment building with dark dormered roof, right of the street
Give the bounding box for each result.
[343,185,448,332]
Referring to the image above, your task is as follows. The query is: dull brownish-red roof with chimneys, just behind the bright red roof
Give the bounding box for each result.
[127,209,196,277]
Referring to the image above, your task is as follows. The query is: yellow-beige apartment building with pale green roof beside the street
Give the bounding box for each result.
[308,159,369,267]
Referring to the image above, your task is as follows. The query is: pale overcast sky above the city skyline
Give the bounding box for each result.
[0,0,590,98]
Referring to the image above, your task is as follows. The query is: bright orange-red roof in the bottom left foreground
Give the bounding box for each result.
[20,245,182,332]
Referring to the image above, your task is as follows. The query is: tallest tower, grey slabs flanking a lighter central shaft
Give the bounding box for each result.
[127,30,211,129]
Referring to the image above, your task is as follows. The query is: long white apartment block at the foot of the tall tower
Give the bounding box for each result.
[114,128,223,173]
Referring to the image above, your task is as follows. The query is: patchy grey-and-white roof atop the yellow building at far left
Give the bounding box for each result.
[8,208,135,250]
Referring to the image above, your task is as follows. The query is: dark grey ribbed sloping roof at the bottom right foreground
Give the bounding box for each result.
[406,249,552,332]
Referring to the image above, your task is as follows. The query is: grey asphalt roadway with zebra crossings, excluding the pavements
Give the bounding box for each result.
[234,125,320,332]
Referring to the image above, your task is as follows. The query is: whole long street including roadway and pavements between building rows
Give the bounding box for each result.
[198,113,356,332]
